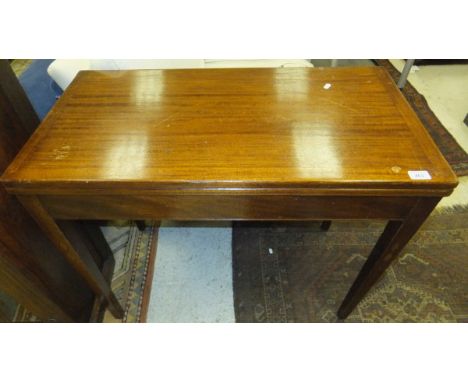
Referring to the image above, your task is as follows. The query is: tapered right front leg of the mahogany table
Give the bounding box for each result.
[338,197,440,319]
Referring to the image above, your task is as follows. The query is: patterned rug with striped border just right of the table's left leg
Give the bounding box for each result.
[7,222,158,323]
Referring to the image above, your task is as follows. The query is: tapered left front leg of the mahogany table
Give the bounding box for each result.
[18,196,124,318]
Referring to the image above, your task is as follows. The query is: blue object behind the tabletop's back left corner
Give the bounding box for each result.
[19,60,63,121]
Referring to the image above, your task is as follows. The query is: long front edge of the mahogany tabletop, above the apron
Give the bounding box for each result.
[0,178,458,196]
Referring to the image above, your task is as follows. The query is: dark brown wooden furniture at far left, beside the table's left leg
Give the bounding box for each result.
[0,60,113,321]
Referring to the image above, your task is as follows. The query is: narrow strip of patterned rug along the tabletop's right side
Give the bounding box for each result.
[373,60,468,176]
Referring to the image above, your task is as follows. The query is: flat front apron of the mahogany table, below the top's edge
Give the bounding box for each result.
[38,194,420,220]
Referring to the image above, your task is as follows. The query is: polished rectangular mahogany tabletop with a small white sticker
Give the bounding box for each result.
[2,67,457,195]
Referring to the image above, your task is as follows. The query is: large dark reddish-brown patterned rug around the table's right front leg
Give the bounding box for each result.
[233,206,468,322]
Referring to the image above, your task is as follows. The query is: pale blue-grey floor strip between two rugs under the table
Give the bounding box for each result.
[148,222,234,322]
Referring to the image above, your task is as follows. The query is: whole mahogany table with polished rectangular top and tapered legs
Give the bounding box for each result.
[1,67,457,318]
